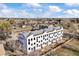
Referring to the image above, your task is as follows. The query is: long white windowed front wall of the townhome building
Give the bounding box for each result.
[27,28,63,53]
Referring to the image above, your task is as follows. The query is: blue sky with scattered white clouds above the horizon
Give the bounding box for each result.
[0,3,79,18]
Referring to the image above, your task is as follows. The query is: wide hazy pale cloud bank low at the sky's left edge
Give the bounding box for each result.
[0,9,34,18]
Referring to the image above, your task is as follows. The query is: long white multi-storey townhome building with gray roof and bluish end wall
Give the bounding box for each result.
[18,26,63,54]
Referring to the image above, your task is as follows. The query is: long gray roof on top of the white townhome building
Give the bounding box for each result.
[19,27,62,37]
